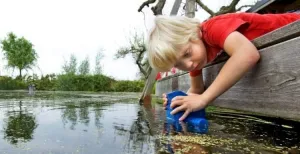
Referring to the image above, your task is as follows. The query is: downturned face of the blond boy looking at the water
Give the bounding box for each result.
[174,40,207,71]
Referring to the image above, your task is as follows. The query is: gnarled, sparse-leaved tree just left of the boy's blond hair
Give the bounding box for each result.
[115,33,149,78]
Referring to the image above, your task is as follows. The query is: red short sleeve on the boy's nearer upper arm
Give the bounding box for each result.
[204,17,249,49]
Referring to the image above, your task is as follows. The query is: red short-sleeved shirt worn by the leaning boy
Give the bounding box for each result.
[190,13,300,76]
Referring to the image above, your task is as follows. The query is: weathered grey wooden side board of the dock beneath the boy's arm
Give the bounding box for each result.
[203,37,300,121]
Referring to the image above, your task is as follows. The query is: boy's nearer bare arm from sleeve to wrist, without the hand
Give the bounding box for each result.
[203,32,260,102]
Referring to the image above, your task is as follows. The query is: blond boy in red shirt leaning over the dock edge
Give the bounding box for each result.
[147,13,300,120]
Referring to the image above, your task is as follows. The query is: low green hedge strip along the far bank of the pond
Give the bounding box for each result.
[0,74,144,92]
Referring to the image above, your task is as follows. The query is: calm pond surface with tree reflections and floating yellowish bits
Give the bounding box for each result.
[0,91,300,154]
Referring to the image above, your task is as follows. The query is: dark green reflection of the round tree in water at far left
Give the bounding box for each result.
[3,101,38,145]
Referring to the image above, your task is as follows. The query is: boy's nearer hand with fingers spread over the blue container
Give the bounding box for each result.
[171,95,209,121]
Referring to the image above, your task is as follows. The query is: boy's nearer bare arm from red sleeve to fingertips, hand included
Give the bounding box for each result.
[171,32,260,120]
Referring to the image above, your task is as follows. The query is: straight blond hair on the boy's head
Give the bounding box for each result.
[147,16,200,72]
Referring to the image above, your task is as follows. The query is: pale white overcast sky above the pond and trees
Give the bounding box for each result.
[0,0,253,80]
